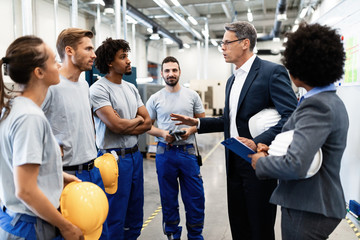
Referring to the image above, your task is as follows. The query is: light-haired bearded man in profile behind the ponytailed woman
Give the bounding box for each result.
[42,28,107,239]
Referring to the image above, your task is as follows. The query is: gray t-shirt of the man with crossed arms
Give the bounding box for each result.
[90,77,144,149]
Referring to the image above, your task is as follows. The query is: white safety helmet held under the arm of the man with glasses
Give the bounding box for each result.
[248,108,281,138]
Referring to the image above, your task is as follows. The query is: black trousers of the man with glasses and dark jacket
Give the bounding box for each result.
[227,152,277,240]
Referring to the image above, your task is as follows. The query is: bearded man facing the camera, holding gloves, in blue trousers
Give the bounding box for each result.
[146,57,205,239]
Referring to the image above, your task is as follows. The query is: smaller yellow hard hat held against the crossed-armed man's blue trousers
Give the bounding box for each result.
[95,153,119,194]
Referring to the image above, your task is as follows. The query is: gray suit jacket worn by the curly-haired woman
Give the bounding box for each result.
[256,91,349,218]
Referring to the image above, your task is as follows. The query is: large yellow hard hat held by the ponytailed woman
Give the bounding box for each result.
[60,182,109,240]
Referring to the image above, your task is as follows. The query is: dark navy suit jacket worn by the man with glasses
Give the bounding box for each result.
[198,57,297,168]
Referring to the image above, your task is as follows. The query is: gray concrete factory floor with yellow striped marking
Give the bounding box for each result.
[138,133,359,240]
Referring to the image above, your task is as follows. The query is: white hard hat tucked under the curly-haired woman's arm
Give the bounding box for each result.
[268,130,322,178]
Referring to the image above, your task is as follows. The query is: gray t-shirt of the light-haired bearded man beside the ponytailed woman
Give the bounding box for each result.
[42,75,97,166]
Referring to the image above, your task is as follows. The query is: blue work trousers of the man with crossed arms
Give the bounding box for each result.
[98,151,144,240]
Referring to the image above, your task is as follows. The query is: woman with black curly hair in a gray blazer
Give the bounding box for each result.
[252,23,349,240]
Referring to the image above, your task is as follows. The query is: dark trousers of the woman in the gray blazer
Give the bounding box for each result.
[281,207,341,240]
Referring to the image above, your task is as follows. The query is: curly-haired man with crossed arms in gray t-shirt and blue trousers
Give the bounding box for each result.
[90,38,151,240]
